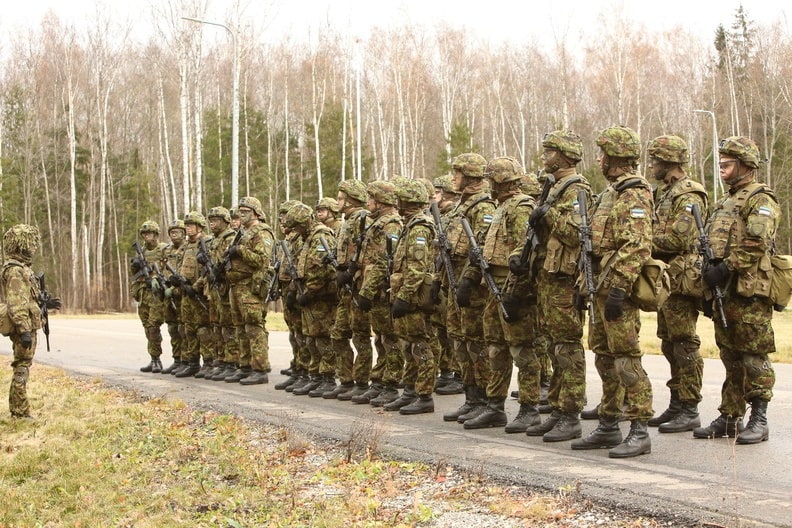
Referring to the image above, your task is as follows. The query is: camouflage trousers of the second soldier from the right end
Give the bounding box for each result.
[657,294,704,402]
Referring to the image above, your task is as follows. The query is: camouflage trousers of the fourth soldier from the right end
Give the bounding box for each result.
[537,269,586,414]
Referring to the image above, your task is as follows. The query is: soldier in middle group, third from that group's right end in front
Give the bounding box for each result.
[322,180,373,401]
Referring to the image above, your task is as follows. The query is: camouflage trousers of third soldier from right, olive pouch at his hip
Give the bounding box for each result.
[589,292,654,421]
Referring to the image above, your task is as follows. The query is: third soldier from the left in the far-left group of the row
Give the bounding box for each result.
[169,211,214,378]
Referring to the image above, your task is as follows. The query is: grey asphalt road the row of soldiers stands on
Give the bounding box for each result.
[7,317,792,527]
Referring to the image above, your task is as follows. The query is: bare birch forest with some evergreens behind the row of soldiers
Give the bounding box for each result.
[0,0,792,313]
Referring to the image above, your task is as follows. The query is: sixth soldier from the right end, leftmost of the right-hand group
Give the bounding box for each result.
[443,152,495,423]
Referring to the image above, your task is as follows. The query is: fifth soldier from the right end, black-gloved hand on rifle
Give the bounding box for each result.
[462,157,541,432]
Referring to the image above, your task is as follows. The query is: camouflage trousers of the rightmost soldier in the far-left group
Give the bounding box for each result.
[229,280,270,372]
